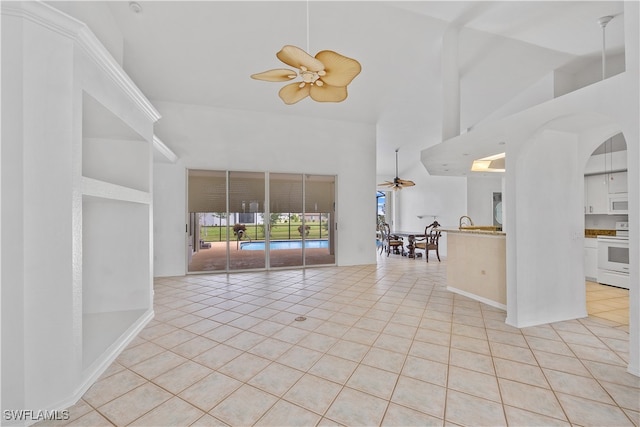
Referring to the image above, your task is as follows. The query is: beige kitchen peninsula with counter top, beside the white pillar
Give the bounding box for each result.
[440,228,507,310]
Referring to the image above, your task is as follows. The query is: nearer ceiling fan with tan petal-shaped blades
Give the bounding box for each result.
[251,45,362,105]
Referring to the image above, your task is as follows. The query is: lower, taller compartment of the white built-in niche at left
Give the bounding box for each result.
[82,196,151,368]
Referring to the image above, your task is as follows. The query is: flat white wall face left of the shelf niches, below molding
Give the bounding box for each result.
[2,10,78,409]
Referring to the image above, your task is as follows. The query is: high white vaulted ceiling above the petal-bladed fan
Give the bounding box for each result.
[75,1,623,178]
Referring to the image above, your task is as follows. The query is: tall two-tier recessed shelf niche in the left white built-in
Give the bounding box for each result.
[79,92,152,370]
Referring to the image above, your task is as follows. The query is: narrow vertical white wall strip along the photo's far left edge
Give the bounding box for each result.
[0,8,25,408]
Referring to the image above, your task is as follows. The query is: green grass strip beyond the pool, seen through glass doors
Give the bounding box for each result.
[200,221,329,242]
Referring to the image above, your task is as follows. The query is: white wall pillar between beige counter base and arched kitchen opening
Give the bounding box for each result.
[507,130,587,327]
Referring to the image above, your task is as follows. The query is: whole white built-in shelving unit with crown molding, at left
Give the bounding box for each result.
[1,2,160,410]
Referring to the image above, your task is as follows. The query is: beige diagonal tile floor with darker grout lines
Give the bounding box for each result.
[43,256,640,426]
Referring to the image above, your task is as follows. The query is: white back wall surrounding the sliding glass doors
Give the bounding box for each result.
[154,102,376,275]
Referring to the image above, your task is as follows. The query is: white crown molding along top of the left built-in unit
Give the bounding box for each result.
[0,1,160,123]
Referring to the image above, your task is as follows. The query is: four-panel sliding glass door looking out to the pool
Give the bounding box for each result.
[187,170,335,272]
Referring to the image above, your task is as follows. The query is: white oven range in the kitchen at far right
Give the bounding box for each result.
[598,222,629,289]
